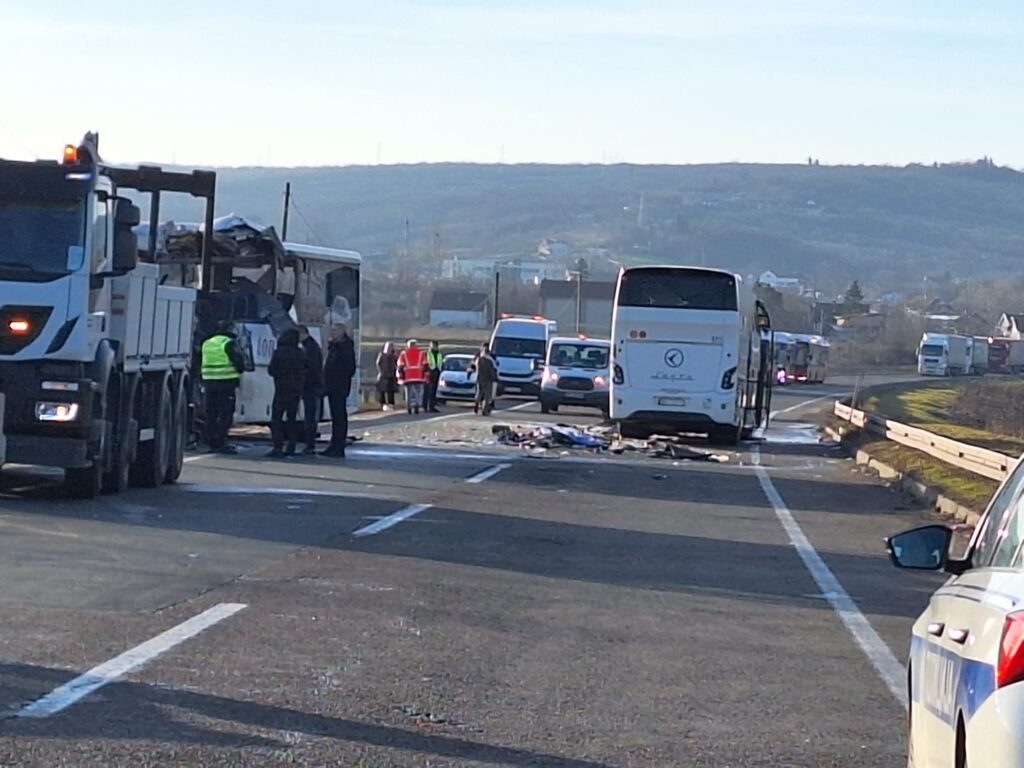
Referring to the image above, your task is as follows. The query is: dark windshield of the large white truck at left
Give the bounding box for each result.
[0,198,85,279]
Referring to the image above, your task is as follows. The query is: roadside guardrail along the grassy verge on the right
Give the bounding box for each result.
[835,400,1020,480]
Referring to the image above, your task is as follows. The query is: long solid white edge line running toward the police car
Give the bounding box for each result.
[754,447,907,709]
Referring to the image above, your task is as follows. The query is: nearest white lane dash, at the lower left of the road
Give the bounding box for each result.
[17,603,246,718]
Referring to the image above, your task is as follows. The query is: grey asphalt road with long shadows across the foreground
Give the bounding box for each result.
[0,382,937,768]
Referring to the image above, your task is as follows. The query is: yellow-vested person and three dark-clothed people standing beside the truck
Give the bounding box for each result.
[202,324,356,458]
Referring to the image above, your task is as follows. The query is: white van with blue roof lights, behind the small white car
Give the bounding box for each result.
[490,316,558,397]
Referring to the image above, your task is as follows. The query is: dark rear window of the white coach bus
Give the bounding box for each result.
[618,269,736,310]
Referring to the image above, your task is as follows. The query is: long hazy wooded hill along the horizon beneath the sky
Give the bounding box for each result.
[155,161,1024,293]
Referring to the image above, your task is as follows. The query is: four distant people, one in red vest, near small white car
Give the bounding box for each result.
[377,339,498,415]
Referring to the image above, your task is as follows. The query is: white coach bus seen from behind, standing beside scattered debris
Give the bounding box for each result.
[610,266,774,444]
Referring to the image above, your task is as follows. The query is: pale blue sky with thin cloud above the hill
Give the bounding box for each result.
[0,0,1024,167]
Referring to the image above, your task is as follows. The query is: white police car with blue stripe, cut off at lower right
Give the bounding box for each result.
[887,461,1024,768]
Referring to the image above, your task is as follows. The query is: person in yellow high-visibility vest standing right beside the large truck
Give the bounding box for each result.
[201,323,246,454]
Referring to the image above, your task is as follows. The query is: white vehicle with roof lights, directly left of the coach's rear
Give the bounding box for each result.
[541,336,611,417]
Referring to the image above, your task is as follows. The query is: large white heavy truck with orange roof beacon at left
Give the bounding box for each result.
[0,134,216,499]
